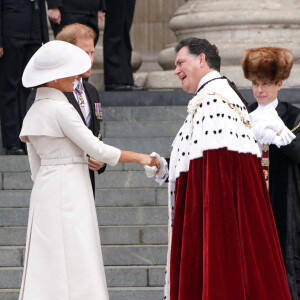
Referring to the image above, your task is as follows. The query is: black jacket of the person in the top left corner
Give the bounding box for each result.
[0,0,49,47]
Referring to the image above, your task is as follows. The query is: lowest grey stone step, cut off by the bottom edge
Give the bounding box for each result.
[0,287,164,300]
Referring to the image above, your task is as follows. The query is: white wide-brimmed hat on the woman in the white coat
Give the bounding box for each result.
[22,41,91,88]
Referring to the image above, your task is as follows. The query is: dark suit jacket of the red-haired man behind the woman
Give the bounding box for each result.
[26,80,106,196]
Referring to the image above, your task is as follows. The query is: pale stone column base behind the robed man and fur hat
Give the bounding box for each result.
[147,0,300,89]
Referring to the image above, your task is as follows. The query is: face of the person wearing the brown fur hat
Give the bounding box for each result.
[252,80,282,105]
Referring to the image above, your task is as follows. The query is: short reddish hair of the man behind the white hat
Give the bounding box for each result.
[56,23,96,45]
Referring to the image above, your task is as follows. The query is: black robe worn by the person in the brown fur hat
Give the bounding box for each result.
[248,102,300,300]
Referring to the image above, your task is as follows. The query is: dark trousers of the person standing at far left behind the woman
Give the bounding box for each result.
[0,37,41,148]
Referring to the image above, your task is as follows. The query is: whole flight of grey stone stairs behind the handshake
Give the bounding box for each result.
[0,104,186,300]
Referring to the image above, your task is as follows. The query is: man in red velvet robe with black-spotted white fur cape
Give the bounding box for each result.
[146,38,291,300]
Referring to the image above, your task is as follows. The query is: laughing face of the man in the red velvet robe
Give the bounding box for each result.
[174,46,203,93]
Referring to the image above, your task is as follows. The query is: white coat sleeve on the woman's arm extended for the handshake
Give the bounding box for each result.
[57,103,121,166]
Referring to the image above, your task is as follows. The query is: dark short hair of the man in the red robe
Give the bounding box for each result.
[175,37,221,72]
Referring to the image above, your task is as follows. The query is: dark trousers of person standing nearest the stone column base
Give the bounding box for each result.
[103,0,135,85]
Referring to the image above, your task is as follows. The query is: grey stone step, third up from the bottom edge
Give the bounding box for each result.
[0,245,167,267]
